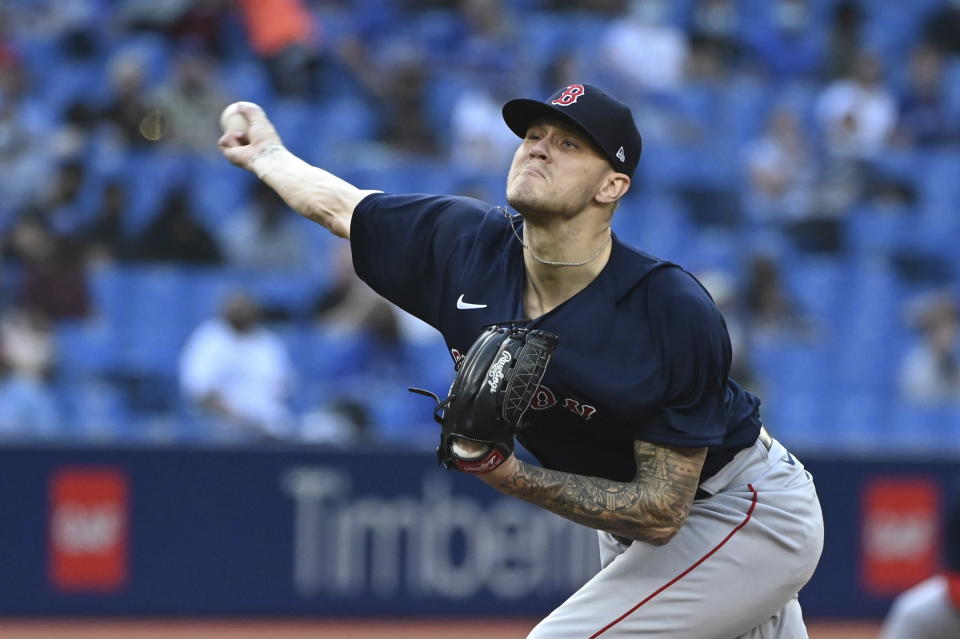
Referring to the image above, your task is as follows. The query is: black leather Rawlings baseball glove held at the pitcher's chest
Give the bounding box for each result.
[410,324,558,473]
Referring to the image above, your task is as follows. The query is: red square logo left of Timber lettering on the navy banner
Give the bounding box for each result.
[49,468,129,591]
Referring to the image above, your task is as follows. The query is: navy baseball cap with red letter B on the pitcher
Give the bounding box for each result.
[503,84,643,177]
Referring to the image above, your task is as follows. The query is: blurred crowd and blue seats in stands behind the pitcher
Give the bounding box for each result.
[0,0,960,453]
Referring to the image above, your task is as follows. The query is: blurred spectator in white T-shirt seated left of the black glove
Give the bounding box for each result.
[180,293,294,440]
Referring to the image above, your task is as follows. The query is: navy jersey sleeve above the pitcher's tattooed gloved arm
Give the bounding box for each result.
[637,267,731,446]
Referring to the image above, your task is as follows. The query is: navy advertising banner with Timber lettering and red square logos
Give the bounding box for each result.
[0,448,958,618]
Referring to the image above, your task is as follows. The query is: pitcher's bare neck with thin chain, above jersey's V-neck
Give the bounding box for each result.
[523,220,612,318]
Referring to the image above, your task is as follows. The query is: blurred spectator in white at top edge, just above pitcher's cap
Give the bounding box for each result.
[599,0,687,92]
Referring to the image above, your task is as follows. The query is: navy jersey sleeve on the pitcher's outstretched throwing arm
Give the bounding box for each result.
[350,193,489,327]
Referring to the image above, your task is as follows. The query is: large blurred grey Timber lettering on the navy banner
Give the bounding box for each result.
[282,466,599,600]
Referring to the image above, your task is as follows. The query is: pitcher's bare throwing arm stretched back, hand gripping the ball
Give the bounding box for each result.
[217,103,377,239]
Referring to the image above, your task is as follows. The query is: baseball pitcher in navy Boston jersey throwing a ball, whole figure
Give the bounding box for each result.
[219,84,823,639]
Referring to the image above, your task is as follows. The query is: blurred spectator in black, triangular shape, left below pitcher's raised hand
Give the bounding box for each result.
[132,187,223,264]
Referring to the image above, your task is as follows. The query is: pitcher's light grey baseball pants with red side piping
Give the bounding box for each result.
[528,432,823,639]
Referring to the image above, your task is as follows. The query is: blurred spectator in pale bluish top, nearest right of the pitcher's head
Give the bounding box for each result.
[746,108,816,222]
